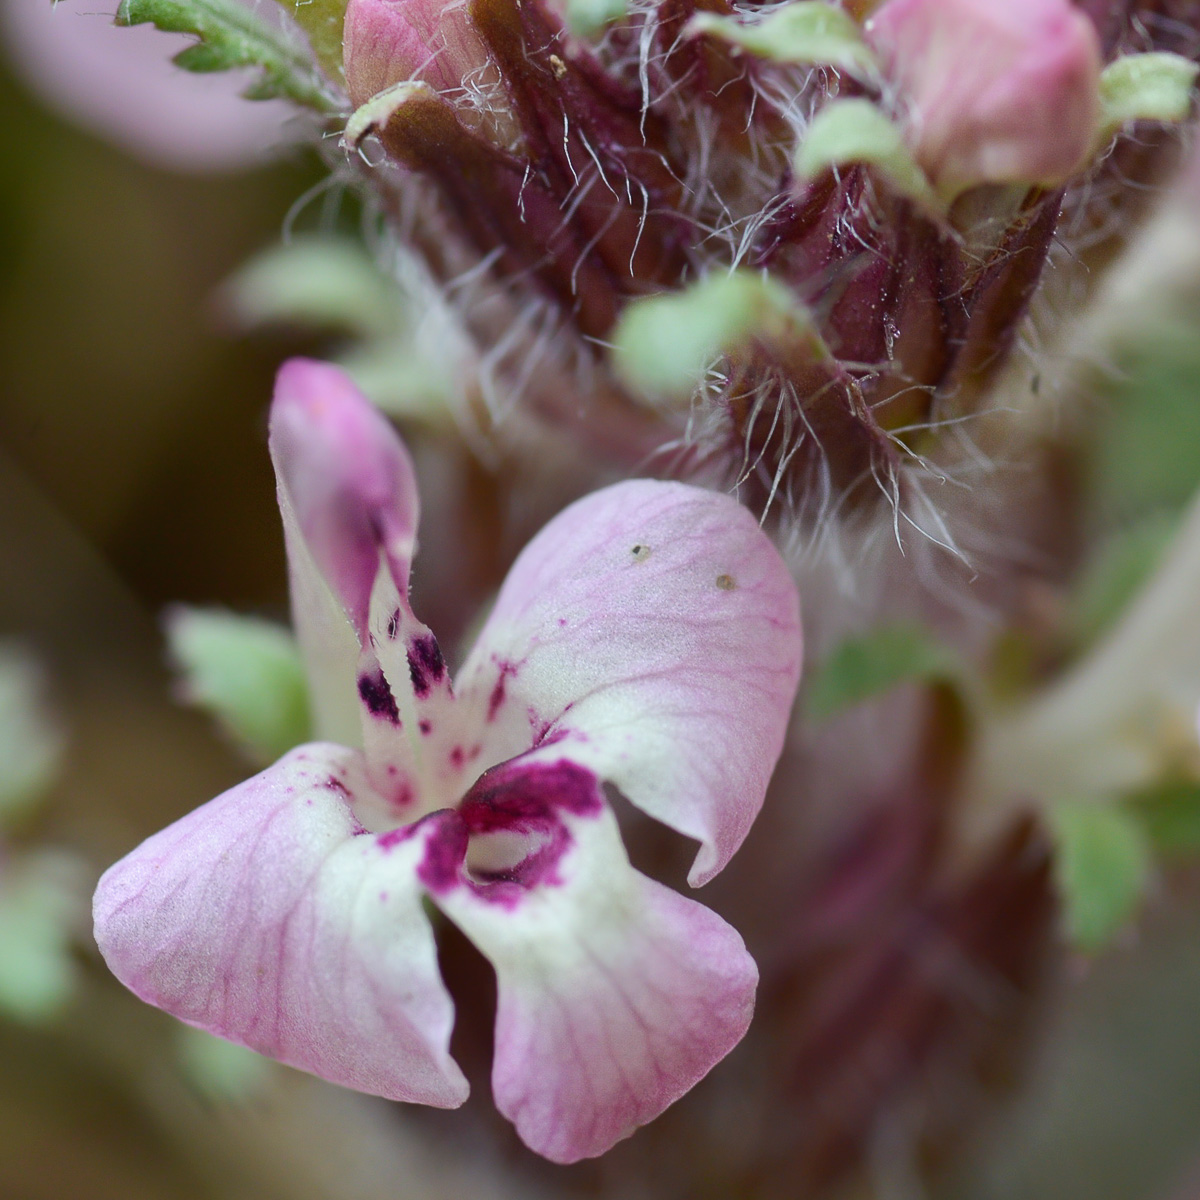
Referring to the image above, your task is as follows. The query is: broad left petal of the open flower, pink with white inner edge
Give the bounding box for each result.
[95,743,467,1108]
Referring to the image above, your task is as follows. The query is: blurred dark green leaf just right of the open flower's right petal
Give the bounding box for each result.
[808,625,958,720]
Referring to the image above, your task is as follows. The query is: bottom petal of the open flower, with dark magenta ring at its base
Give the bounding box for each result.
[421,760,758,1163]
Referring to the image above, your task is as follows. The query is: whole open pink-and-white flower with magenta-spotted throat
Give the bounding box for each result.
[95,361,800,1162]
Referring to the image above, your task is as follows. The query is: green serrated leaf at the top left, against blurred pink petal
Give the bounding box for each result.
[116,0,341,113]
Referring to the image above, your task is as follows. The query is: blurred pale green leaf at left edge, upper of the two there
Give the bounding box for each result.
[0,642,62,827]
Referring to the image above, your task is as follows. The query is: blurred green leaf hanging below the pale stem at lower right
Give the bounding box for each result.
[1049,800,1151,954]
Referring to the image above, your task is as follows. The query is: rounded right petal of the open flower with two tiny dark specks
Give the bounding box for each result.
[460,480,800,884]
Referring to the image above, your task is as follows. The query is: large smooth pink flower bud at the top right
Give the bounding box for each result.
[866,0,1100,197]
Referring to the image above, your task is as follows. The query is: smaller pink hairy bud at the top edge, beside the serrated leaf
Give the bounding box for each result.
[342,0,488,104]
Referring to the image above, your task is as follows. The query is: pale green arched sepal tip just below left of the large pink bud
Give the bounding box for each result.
[793,98,942,214]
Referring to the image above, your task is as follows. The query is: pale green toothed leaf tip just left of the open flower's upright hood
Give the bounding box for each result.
[167,606,311,762]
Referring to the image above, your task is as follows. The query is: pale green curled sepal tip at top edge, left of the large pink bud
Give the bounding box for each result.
[686,0,878,78]
